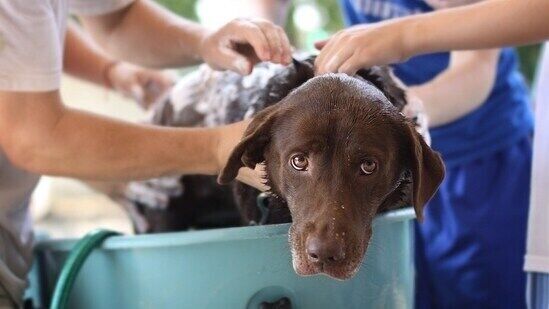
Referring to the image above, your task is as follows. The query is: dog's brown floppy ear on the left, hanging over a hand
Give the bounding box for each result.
[217,105,279,184]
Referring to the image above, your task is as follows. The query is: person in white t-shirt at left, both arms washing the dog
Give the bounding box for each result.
[0,0,291,307]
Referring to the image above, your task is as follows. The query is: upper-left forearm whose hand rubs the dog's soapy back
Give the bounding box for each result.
[81,0,207,67]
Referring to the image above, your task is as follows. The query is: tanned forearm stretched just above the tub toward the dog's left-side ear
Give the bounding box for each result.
[29,109,217,180]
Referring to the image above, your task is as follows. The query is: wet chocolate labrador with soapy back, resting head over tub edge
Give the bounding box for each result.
[121,57,444,280]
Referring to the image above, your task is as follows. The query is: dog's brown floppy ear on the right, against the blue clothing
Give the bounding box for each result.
[404,122,445,221]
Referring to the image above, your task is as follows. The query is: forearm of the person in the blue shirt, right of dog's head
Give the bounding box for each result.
[409,49,499,126]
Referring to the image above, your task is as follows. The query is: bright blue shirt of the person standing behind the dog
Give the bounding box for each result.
[341,0,533,166]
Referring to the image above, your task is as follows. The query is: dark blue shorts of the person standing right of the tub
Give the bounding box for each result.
[415,137,532,309]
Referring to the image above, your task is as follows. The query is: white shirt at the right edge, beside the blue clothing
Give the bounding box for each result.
[524,43,549,273]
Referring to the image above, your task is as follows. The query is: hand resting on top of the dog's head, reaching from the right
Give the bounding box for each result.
[315,21,409,75]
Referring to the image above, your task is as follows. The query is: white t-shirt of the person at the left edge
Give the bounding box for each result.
[0,0,133,304]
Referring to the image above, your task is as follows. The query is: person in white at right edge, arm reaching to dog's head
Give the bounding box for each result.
[315,0,549,309]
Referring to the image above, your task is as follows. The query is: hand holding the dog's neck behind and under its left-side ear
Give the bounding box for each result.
[215,119,269,191]
